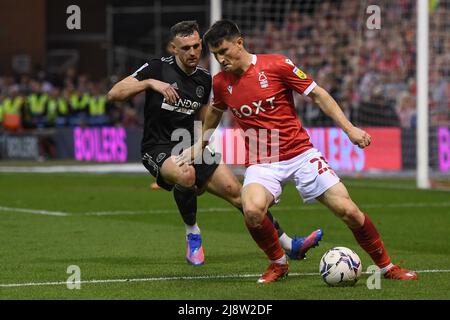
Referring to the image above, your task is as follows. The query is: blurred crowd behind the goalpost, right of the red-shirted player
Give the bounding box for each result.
[246,0,450,128]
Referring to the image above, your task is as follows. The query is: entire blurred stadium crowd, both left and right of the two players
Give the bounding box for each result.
[0,0,450,130]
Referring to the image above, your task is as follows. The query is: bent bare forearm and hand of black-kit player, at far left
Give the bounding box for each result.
[107,76,179,104]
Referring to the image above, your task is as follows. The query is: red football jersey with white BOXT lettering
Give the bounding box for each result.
[213,54,316,166]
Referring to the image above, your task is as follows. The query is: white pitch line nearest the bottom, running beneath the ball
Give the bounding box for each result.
[0,269,450,288]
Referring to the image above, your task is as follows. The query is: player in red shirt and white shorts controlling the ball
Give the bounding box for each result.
[178,20,417,283]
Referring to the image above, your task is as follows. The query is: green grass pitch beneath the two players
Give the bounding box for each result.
[0,174,450,300]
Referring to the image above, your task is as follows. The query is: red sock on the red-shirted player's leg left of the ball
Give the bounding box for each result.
[246,215,284,260]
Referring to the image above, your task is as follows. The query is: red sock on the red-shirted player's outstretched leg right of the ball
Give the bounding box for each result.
[350,214,391,268]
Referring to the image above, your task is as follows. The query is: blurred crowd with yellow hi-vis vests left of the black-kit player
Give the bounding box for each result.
[0,69,142,130]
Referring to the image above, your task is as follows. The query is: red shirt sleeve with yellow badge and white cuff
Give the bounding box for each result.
[278,57,317,96]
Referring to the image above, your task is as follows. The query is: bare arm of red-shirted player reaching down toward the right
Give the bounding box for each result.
[308,86,372,148]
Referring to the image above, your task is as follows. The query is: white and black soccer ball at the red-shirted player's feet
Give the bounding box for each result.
[319,247,362,287]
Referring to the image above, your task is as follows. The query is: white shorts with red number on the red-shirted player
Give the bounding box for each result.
[244,148,340,203]
